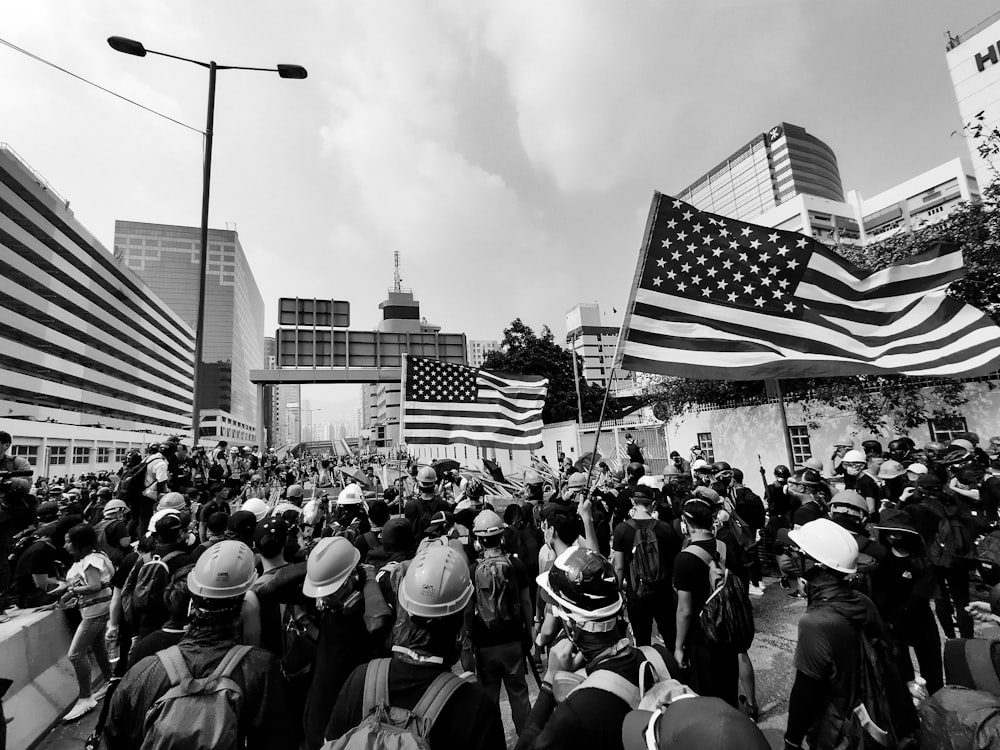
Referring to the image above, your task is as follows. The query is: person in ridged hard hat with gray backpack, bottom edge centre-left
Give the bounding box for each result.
[325,545,506,750]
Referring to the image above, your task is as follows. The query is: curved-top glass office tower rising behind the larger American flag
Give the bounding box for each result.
[677,122,844,219]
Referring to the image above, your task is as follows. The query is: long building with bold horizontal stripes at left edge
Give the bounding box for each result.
[0,144,194,434]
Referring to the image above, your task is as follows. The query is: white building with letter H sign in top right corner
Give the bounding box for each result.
[945,13,1000,187]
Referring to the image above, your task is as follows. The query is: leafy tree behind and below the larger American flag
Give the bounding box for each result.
[646,176,1000,434]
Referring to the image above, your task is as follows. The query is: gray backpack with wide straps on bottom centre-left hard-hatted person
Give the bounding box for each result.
[323,659,465,750]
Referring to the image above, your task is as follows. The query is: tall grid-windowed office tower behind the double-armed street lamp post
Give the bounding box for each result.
[115,221,265,443]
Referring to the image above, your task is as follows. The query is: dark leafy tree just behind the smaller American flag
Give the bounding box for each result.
[483,318,604,424]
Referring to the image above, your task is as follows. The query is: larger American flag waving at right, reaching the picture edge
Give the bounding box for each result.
[618,193,1000,380]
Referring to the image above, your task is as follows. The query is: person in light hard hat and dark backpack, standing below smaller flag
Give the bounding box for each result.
[469,510,532,733]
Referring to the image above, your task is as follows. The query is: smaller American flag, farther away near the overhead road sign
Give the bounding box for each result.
[403,356,549,450]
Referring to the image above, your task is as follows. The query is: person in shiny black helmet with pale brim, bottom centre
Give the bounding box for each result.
[517,546,678,750]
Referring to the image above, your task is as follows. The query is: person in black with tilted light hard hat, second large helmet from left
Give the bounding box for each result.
[300,537,378,750]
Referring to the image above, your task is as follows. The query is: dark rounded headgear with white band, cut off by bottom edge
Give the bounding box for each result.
[622,696,771,750]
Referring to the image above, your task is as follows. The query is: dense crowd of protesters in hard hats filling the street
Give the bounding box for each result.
[0,432,1000,750]
